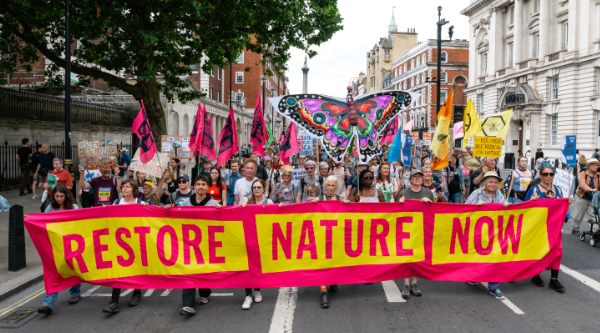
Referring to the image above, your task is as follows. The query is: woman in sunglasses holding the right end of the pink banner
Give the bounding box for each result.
[525,160,572,293]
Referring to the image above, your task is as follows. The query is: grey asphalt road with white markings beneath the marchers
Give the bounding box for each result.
[0,218,600,333]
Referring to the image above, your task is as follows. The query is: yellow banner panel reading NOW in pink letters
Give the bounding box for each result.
[432,208,550,265]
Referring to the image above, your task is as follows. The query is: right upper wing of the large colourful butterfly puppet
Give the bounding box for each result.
[356,90,413,134]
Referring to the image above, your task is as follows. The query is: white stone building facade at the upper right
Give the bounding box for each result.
[461,0,600,158]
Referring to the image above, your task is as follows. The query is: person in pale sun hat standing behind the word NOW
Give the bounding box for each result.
[465,171,510,299]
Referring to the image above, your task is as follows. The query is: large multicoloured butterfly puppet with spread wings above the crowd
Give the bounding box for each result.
[269,88,419,163]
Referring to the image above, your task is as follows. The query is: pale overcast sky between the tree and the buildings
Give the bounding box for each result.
[288,0,470,98]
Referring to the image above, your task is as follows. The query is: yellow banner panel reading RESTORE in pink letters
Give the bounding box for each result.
[47,217,248,281]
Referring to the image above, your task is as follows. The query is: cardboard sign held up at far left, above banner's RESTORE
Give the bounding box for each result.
[77,140,117,170]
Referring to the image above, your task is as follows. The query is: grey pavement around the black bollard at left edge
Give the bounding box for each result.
[0,190,43,300]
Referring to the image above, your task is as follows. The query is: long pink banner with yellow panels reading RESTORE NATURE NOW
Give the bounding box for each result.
[25,199,568,293]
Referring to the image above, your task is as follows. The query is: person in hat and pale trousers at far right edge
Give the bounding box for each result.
[570,158,600,236]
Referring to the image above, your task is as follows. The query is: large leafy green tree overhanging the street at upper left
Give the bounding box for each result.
[0,0,342,140]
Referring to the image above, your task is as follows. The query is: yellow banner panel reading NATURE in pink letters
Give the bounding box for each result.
[256,212,425,273]
